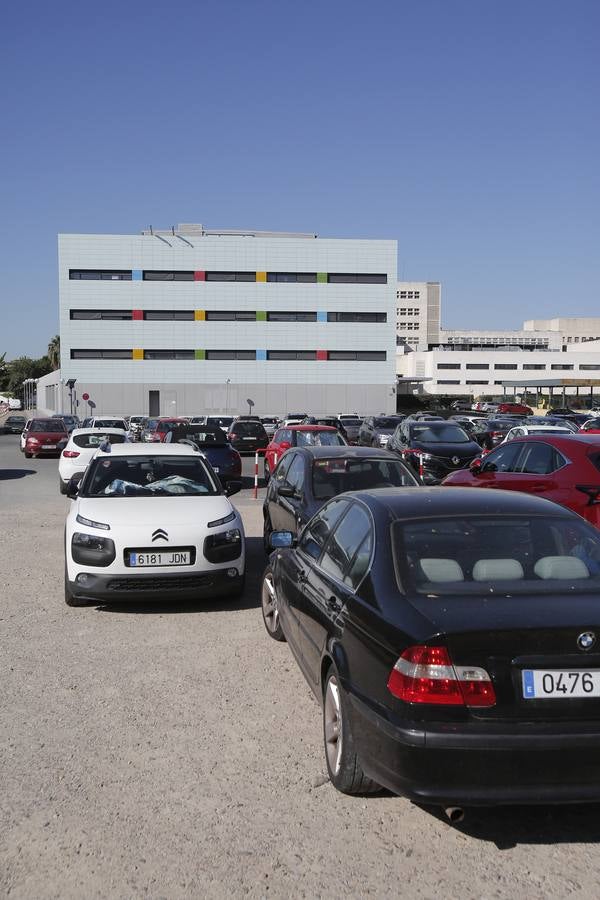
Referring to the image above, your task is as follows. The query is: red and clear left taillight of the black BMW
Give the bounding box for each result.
[387,645,496,706]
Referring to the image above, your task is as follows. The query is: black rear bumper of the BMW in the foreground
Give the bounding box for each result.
[349,695,600,806]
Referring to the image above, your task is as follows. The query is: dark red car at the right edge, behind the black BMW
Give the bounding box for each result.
[442,432,600,528]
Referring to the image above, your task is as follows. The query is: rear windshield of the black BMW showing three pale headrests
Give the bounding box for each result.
[391,515,600,603]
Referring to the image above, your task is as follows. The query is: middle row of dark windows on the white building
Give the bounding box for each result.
[70,309,387,323]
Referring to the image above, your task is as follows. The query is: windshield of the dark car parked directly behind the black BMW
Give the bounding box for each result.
[312,456,418,500]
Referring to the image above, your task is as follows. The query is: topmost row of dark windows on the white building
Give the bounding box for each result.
[69,269,387,284]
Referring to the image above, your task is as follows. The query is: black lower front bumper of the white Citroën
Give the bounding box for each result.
[69,560,244,603]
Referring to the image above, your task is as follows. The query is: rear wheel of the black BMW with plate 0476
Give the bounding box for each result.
[323,666,380,794]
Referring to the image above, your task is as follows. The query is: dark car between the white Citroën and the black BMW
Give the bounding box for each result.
[263,447,419,551]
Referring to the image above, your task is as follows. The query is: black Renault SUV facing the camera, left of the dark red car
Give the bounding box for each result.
[388,420,481,484]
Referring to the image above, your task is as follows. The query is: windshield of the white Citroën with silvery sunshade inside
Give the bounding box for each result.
[80,455,220,497]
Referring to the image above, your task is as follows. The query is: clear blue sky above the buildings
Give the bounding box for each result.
[0,0,600,359]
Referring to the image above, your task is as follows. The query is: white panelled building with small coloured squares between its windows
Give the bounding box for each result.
[38,225,397,416]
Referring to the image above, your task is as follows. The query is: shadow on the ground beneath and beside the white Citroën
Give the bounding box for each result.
[91,537,267,615]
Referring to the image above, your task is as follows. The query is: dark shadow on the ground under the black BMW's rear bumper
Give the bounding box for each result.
[420,803,600,850]
